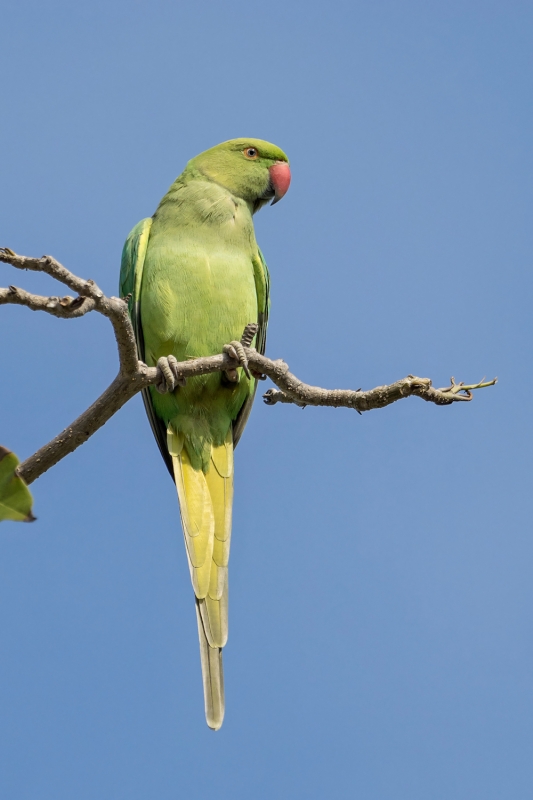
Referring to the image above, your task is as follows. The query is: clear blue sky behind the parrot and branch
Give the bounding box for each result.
[0,0,533,800]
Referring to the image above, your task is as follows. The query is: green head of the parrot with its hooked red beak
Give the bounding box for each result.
[189,139,291,213]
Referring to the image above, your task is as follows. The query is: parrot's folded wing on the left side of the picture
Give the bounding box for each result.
[120,217,174,477]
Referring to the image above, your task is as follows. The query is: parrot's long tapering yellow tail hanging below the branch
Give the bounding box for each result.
[167,427,233,730]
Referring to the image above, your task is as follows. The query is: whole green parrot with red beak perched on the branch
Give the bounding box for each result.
[120,139,291,730]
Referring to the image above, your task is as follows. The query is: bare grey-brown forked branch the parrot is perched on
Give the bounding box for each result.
[0,248,496,484]
